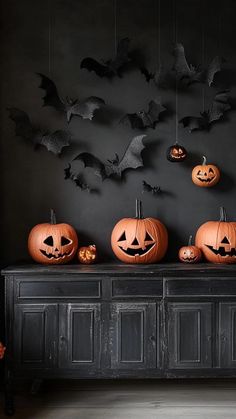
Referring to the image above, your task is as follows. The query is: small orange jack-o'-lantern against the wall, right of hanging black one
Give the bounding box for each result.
[192,156,220,188]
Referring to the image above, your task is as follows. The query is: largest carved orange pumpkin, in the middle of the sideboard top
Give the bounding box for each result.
[111,200,168,263]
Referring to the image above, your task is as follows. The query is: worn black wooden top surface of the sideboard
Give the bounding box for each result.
[1,263,236,277]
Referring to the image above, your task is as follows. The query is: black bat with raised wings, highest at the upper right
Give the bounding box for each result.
[173,43,224,86]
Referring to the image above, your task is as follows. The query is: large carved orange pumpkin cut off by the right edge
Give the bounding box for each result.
[195,207,236,263]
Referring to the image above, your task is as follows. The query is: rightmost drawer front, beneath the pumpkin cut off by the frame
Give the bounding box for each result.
[165,277,236,297]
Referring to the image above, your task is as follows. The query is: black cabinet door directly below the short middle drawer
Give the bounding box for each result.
[110,303,159,369]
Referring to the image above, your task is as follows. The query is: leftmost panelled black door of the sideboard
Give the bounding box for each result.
[13,304,58,369]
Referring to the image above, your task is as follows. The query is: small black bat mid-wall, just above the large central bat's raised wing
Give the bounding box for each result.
[120,100,166,129]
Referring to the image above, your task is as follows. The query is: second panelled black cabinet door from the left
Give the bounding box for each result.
[59,303,101,370]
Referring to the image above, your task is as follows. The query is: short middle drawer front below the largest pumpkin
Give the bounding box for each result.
[112,278,163,298]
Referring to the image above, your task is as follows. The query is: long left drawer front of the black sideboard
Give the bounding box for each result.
[16,277,101,299]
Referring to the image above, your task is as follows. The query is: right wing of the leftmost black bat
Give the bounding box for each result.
[41,130,71,155]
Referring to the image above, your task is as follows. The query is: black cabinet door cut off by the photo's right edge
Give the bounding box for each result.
[219,302,236,368]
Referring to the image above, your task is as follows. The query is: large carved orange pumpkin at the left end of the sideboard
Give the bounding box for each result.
[28,210,78,265]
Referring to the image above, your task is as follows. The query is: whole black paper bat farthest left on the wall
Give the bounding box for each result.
[8,108,71,155]
